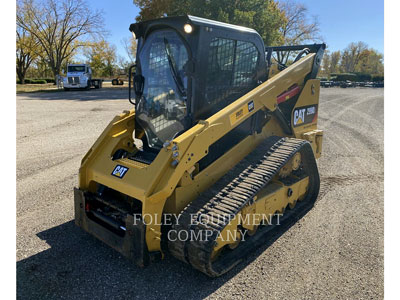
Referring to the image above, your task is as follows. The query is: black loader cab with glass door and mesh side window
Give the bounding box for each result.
[129,16,267,151]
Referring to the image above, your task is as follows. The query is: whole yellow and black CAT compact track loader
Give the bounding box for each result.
[74,16,325,277]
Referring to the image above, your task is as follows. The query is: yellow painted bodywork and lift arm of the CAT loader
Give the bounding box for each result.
[79,53,322,251]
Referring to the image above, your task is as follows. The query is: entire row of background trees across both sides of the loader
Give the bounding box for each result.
[16,0,383,83]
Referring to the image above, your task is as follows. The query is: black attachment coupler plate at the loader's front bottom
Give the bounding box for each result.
[74,188,150,267]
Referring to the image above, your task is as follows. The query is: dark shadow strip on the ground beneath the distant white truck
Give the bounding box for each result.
[17,87,128,101]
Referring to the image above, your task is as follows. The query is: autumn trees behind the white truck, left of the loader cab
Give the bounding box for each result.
[16,0,136,84]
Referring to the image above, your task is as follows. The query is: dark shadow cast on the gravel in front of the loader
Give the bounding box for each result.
[17,213,306,299]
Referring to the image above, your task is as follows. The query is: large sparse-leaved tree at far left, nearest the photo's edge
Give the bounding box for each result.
[17,0,104,77]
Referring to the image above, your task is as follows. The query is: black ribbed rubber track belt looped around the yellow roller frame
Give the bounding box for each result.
[168,136,320,277]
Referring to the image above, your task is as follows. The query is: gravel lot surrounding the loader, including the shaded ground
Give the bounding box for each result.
[17,88,384,299]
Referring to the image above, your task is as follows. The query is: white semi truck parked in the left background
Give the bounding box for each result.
[63,64,103,91]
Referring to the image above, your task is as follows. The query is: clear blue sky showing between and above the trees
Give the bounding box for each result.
[94,0,384,57]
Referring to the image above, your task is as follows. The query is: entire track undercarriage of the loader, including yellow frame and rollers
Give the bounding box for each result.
[168,137,319,277]
